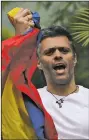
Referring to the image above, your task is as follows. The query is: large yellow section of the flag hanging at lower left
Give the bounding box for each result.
[2,76,37,140]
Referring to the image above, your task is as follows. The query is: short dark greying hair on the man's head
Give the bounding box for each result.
[37,25,76,56]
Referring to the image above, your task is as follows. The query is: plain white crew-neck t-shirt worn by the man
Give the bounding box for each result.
[38,86,89,139]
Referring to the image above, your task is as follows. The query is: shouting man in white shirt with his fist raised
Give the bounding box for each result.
[2,9,89,139]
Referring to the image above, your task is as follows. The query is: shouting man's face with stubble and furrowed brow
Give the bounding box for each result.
[38,36,75,85]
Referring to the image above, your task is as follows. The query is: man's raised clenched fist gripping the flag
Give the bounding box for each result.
[9,8,34,35]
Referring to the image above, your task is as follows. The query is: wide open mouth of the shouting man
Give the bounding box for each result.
[53,63,66,74]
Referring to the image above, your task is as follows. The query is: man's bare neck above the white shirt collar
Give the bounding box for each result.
[47,77,78,96]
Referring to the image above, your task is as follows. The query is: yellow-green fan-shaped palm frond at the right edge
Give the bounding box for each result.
[70,8,89,47]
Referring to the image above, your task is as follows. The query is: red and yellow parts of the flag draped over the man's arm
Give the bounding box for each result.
[2,7,58,140]
